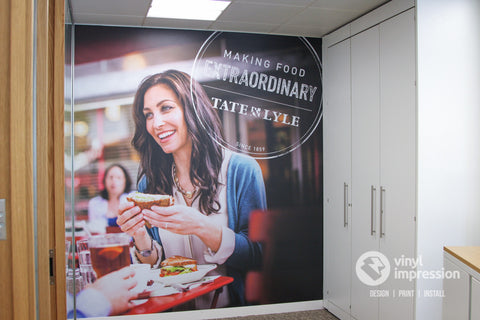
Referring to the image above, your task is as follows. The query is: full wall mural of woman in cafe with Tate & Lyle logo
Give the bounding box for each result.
[65,26,323,317]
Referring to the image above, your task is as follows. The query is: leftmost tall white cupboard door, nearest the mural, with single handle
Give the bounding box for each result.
[323,40,351,318]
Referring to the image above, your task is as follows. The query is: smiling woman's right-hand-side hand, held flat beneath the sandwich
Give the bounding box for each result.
[142,205,222,251]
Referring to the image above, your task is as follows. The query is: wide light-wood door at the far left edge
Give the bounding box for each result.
[0,0,35,319]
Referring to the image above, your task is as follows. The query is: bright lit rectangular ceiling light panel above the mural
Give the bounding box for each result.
[147,0,231,21]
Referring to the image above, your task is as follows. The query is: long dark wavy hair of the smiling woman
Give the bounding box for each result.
[132,70,223,215]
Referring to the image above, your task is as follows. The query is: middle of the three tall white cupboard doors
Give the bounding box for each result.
[351,27,380,320]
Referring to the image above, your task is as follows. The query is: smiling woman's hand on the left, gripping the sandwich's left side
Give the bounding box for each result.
[117,202,147,238]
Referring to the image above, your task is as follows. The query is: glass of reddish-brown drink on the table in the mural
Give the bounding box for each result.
[88,233,131,278]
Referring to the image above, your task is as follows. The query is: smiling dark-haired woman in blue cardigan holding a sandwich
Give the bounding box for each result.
[117,70,266,309]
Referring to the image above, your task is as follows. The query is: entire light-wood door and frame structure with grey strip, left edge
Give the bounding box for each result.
[0,0,66,319]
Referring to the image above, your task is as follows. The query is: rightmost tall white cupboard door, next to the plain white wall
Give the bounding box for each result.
[379,9,416,320]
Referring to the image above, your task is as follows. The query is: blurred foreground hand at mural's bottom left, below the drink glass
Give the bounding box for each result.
[88,267,138,315]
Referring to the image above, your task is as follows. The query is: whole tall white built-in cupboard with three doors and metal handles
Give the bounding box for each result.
[324,5,416,320]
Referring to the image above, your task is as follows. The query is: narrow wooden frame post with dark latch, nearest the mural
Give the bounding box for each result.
[36,0,66,319]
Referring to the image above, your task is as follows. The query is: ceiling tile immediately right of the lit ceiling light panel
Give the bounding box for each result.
[218,3,302,24]
